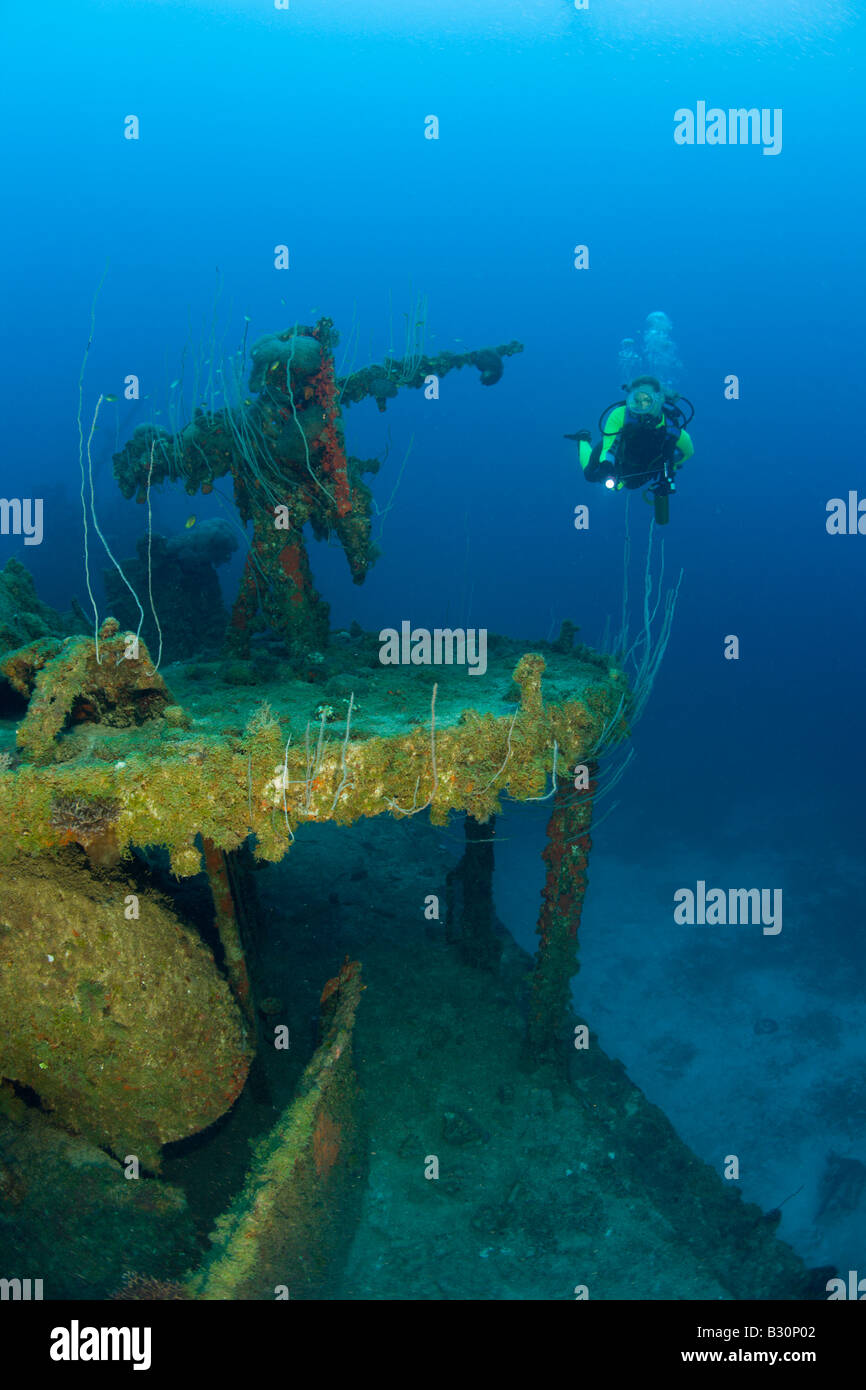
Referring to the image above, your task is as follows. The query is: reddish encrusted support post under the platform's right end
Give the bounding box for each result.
[530,763,598,1054]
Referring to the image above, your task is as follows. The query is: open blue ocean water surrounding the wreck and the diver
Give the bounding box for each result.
[0,0,866,1301]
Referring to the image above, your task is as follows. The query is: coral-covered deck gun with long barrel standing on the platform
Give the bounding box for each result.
[114,318,523,656]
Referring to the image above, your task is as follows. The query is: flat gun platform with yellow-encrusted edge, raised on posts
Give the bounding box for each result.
[0,623,628,877]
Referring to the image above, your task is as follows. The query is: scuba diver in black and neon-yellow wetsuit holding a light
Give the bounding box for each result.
[566,377,695,525]
